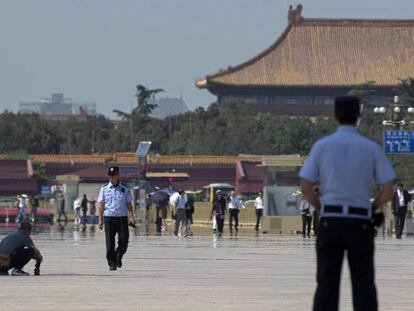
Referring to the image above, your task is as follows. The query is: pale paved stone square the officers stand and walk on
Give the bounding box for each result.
[0,228,414,311]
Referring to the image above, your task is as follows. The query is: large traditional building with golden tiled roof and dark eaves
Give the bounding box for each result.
[196,5,414,115]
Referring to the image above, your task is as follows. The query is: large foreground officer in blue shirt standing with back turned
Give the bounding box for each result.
[299,96,395,311]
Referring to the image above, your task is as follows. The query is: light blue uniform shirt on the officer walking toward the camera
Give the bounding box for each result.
[98,182,132,217]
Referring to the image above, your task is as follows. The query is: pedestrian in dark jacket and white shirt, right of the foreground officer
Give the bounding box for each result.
[391,183,411,239]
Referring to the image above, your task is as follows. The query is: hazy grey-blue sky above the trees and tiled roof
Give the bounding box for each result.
[0,0,414,117]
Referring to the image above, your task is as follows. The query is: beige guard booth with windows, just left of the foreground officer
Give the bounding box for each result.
[260,154,304,233]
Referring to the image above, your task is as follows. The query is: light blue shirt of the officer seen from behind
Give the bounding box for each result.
[299,126,395,218]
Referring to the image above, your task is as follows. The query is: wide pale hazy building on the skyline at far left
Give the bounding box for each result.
[19,93,96,120]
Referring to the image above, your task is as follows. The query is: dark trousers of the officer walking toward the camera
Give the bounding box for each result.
[104,216,129,266]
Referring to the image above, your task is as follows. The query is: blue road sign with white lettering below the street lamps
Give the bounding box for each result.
[383,131,414,154]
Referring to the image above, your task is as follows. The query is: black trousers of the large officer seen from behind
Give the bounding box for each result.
[313,217,378,311]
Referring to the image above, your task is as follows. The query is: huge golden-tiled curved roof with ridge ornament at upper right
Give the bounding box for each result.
[196,5,414,93]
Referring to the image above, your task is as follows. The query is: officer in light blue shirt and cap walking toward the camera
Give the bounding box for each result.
[98,166,135,271]
